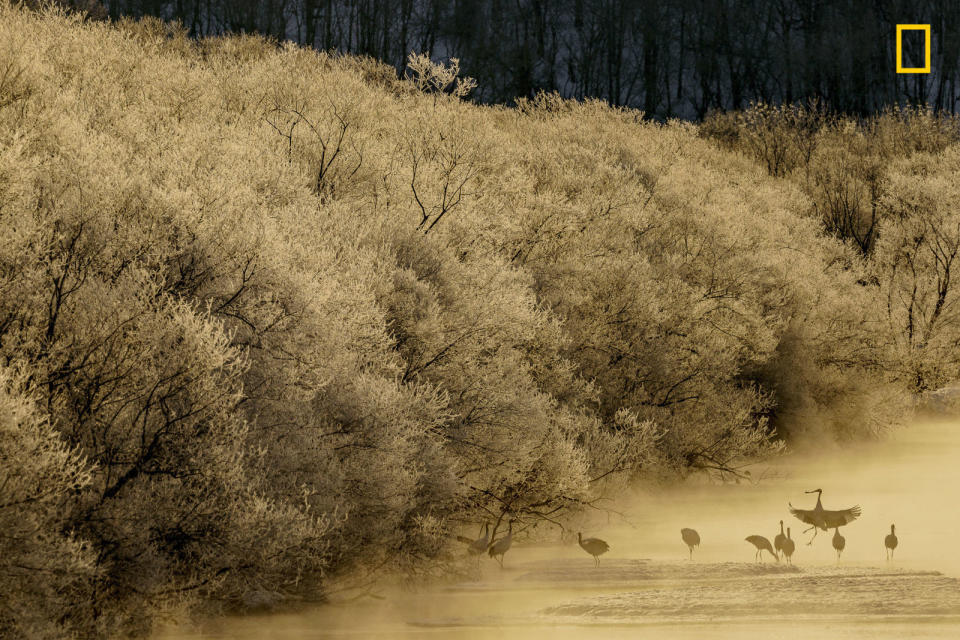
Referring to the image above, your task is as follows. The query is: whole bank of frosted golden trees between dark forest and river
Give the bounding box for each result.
[0,3,960,637]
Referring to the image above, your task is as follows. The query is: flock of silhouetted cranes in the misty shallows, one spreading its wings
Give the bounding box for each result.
[457,489,898,567]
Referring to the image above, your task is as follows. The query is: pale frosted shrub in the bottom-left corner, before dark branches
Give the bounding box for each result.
[0,368,97,637]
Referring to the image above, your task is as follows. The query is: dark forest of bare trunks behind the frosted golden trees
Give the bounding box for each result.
[90,0,960,118]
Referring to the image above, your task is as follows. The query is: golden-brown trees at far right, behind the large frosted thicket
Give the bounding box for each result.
[700,104,960,392]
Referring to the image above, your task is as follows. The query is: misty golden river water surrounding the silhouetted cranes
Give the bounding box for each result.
[156,421,960,640]
